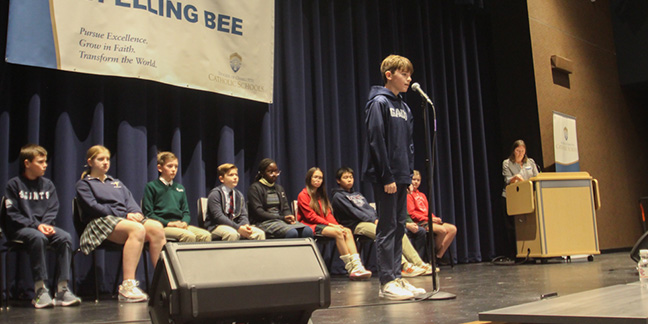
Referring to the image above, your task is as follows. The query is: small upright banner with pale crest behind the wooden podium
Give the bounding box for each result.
[553,111,580,172]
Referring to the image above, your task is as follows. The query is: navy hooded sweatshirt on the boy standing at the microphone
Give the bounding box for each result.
[362,86,414,186]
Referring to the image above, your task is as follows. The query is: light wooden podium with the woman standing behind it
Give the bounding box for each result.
[506,172,601,258]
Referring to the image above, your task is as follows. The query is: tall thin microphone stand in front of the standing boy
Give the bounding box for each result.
[421,92,457,300]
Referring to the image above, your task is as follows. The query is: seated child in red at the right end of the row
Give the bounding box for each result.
[407,170,457,259]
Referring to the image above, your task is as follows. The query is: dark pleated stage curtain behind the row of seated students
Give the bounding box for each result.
[0,0,501,289]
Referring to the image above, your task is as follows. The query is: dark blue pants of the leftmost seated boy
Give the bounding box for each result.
[12,227,72,282]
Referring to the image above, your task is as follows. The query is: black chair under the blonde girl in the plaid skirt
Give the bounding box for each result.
[72,198,149,303]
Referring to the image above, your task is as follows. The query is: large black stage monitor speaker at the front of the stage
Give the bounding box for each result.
[149,238,331,324]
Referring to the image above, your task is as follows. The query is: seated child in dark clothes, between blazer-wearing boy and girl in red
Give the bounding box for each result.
[247,158,313,238]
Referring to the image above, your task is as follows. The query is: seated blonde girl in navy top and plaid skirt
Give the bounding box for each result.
[76,145,166,303]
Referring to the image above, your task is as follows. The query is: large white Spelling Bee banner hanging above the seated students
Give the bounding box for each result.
[6,0,274,103]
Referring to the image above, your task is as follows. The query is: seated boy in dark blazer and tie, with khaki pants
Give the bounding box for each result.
[205,163,265,241]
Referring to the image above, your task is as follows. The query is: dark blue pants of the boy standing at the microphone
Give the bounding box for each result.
[373,183,408,285]
